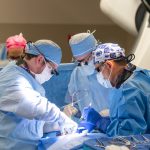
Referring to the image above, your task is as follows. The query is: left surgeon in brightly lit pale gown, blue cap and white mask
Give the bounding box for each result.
[0,40,77,150]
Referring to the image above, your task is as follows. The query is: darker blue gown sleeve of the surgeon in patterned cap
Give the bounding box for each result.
[107,85,148,136]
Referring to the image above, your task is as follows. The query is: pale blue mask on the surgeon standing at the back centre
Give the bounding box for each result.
[80,60,95,76]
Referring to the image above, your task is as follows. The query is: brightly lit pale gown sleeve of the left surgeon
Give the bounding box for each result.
[0,67,77,129]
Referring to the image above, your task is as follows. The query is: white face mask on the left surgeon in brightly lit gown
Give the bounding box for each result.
[35,65,53,84]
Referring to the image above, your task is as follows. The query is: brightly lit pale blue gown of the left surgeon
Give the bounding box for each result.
[0,62,72,150]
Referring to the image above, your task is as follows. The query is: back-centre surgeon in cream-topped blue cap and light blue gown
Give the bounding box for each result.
[64,31,109,116]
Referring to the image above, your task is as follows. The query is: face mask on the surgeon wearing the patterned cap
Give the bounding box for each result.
[96,66,113,88]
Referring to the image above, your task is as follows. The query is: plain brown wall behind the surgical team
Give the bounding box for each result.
[0,0,136,63]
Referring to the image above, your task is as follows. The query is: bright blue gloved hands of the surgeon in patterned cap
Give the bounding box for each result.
[78,106,110,133]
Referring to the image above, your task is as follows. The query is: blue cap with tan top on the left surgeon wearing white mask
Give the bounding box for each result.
[26,40,62,65]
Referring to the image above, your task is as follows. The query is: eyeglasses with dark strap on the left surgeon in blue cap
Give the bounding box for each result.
[27,41,59,75]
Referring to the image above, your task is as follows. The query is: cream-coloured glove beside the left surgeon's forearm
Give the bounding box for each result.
[63,104,78,118]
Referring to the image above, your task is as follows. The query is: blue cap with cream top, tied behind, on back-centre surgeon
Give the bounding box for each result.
[69,33,97,57]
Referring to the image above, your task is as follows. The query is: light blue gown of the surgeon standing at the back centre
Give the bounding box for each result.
[68,66,111,112]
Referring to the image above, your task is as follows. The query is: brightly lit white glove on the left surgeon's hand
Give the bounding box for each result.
[60,112,78,135]
